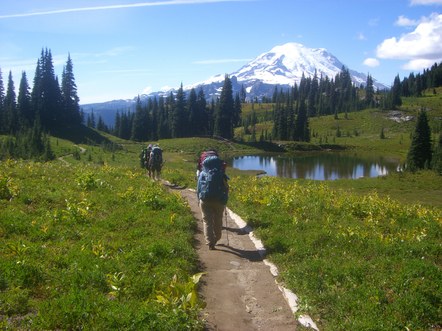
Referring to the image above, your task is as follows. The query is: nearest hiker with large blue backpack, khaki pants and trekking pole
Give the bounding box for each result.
[197,150,229,250]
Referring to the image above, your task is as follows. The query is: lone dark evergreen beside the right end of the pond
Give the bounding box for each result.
[406,111,431,171]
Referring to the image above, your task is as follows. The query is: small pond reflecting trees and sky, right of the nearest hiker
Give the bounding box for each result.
[230,153,398,180]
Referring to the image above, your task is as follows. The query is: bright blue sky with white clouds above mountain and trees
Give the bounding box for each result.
[0,0,442,104]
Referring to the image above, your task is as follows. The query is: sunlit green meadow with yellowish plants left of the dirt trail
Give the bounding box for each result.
[0,159,202,330]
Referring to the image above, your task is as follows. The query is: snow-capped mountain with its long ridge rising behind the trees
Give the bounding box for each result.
[82,43,387,125]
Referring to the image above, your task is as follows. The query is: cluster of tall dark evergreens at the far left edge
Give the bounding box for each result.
[0,49,82,161]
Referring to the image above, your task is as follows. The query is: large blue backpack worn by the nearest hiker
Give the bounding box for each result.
[197,155,229,205]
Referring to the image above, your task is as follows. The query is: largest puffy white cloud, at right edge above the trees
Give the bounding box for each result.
[376,14,442,69]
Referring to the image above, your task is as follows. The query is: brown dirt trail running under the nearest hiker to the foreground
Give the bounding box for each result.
[172,189,297,331]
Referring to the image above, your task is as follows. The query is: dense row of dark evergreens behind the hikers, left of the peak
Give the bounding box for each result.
[110,77,241,141]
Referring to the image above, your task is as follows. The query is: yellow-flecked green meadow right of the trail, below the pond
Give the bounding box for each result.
[230,177,442,330]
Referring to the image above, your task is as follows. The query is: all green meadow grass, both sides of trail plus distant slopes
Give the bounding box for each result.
[0,91,442,330]
